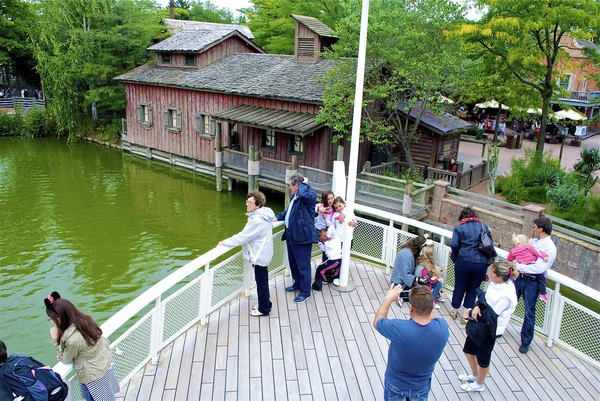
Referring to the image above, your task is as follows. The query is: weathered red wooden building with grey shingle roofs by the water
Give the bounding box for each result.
[115,15,370,181]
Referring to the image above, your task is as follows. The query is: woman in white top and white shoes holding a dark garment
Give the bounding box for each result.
[458,262,519,392]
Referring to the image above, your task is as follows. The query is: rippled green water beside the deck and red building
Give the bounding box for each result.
[0,138,283,364]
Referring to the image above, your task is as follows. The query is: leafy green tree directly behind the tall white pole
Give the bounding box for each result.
[318,0,464,167]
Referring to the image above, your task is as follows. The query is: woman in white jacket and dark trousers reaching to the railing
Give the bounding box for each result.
[219,192,275,316]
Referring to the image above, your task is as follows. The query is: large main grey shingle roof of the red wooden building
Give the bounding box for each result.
[114,54,334,105]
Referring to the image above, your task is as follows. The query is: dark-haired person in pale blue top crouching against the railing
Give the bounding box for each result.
[390,235,427,306]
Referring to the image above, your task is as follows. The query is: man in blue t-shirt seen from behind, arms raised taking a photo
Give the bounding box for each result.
[373,284,450,401]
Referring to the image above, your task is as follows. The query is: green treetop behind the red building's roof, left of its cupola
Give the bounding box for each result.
[245,0,345,54]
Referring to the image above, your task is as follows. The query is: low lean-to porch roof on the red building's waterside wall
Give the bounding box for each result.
[215,105,323,136]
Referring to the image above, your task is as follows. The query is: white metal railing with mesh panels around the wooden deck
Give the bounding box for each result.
[54,204,600,400]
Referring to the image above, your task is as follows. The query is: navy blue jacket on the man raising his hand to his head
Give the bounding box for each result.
[276,183,318,244]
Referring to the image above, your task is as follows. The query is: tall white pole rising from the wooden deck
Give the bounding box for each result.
[340,0,369,287]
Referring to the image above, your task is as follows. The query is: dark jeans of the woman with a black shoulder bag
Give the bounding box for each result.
[452,261,489,309]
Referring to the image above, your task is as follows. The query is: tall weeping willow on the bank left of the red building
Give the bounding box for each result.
[31,0,165,136]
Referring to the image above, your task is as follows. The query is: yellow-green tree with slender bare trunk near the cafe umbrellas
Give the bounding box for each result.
[460,0,600,154]
